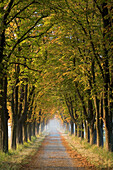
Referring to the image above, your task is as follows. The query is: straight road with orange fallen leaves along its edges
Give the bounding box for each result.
[22,131,94,170]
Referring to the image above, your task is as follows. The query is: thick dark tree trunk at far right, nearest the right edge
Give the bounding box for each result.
[102,2,111,151]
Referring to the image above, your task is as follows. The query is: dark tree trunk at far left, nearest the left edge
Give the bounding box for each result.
[0,0,14,152]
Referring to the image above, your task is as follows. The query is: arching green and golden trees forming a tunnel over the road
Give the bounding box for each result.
[0,0,113,152]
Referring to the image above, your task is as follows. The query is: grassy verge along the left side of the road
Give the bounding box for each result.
[0,135,45,170]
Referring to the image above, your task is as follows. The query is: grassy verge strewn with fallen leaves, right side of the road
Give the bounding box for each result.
[64,134,113,170]
